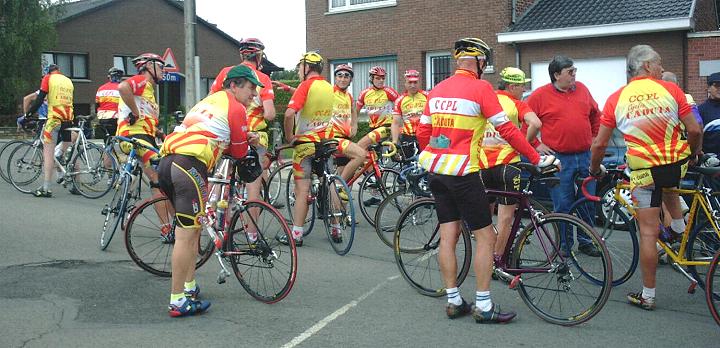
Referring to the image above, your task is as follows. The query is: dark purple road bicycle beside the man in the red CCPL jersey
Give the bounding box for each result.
[394,163,612,326]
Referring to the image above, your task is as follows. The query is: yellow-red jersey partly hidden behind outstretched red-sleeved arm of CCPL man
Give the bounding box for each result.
[480,91,532,169]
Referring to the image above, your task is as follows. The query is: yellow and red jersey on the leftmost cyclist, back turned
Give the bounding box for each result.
[40,71,75,122]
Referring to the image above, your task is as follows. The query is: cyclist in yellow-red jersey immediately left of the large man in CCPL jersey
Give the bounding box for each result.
[390,69,428,158]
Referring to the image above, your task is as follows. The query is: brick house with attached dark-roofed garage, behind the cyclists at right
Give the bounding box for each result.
[305,0,720,106]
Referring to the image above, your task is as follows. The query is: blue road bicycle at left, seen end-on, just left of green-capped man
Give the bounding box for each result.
[99,135,160,250]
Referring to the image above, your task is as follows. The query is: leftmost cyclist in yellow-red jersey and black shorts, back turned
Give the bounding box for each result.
[28,64,75,197]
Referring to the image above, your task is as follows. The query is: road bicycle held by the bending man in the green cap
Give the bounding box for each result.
[125,156,297,303]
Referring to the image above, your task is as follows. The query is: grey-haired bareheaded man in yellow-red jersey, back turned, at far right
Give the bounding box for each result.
[589,45,702,310]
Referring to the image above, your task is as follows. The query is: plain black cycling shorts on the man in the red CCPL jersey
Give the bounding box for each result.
[428,173,492,231]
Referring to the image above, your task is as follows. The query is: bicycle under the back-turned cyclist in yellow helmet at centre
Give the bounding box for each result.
[285,139,356,256]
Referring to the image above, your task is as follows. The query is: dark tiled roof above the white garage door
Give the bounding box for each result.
[509,0,695,32]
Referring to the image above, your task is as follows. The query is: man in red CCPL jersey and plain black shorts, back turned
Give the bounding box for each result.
[416,38,557,323]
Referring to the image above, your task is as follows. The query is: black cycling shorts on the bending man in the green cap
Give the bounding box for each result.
[158,155,207,228]
